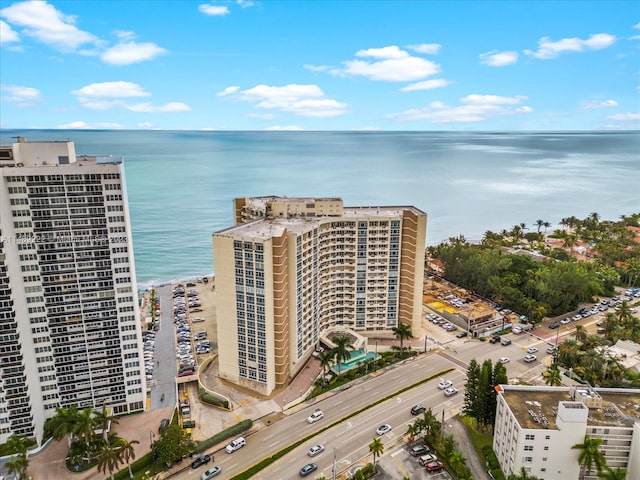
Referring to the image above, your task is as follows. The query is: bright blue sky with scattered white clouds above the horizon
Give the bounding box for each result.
[0,0,640,131]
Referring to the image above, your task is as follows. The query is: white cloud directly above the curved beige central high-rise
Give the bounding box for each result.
[224,84,347,117]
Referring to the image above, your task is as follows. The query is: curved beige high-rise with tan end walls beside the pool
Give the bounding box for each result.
[213,197,427,395]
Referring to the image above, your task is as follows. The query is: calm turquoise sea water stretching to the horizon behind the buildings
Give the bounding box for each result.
[0,130,640,287]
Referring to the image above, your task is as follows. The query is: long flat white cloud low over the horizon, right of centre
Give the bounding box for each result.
[390,94,533,123]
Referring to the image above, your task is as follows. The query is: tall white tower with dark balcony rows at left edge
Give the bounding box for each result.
[0,138,146,442]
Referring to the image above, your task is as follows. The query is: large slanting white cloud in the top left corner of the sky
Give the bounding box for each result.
[0,0,100,51]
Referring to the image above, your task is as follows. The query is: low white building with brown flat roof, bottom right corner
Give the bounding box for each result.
[493,385,640,480]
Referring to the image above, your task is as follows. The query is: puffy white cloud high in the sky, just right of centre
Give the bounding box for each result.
[331,45,440,82]
